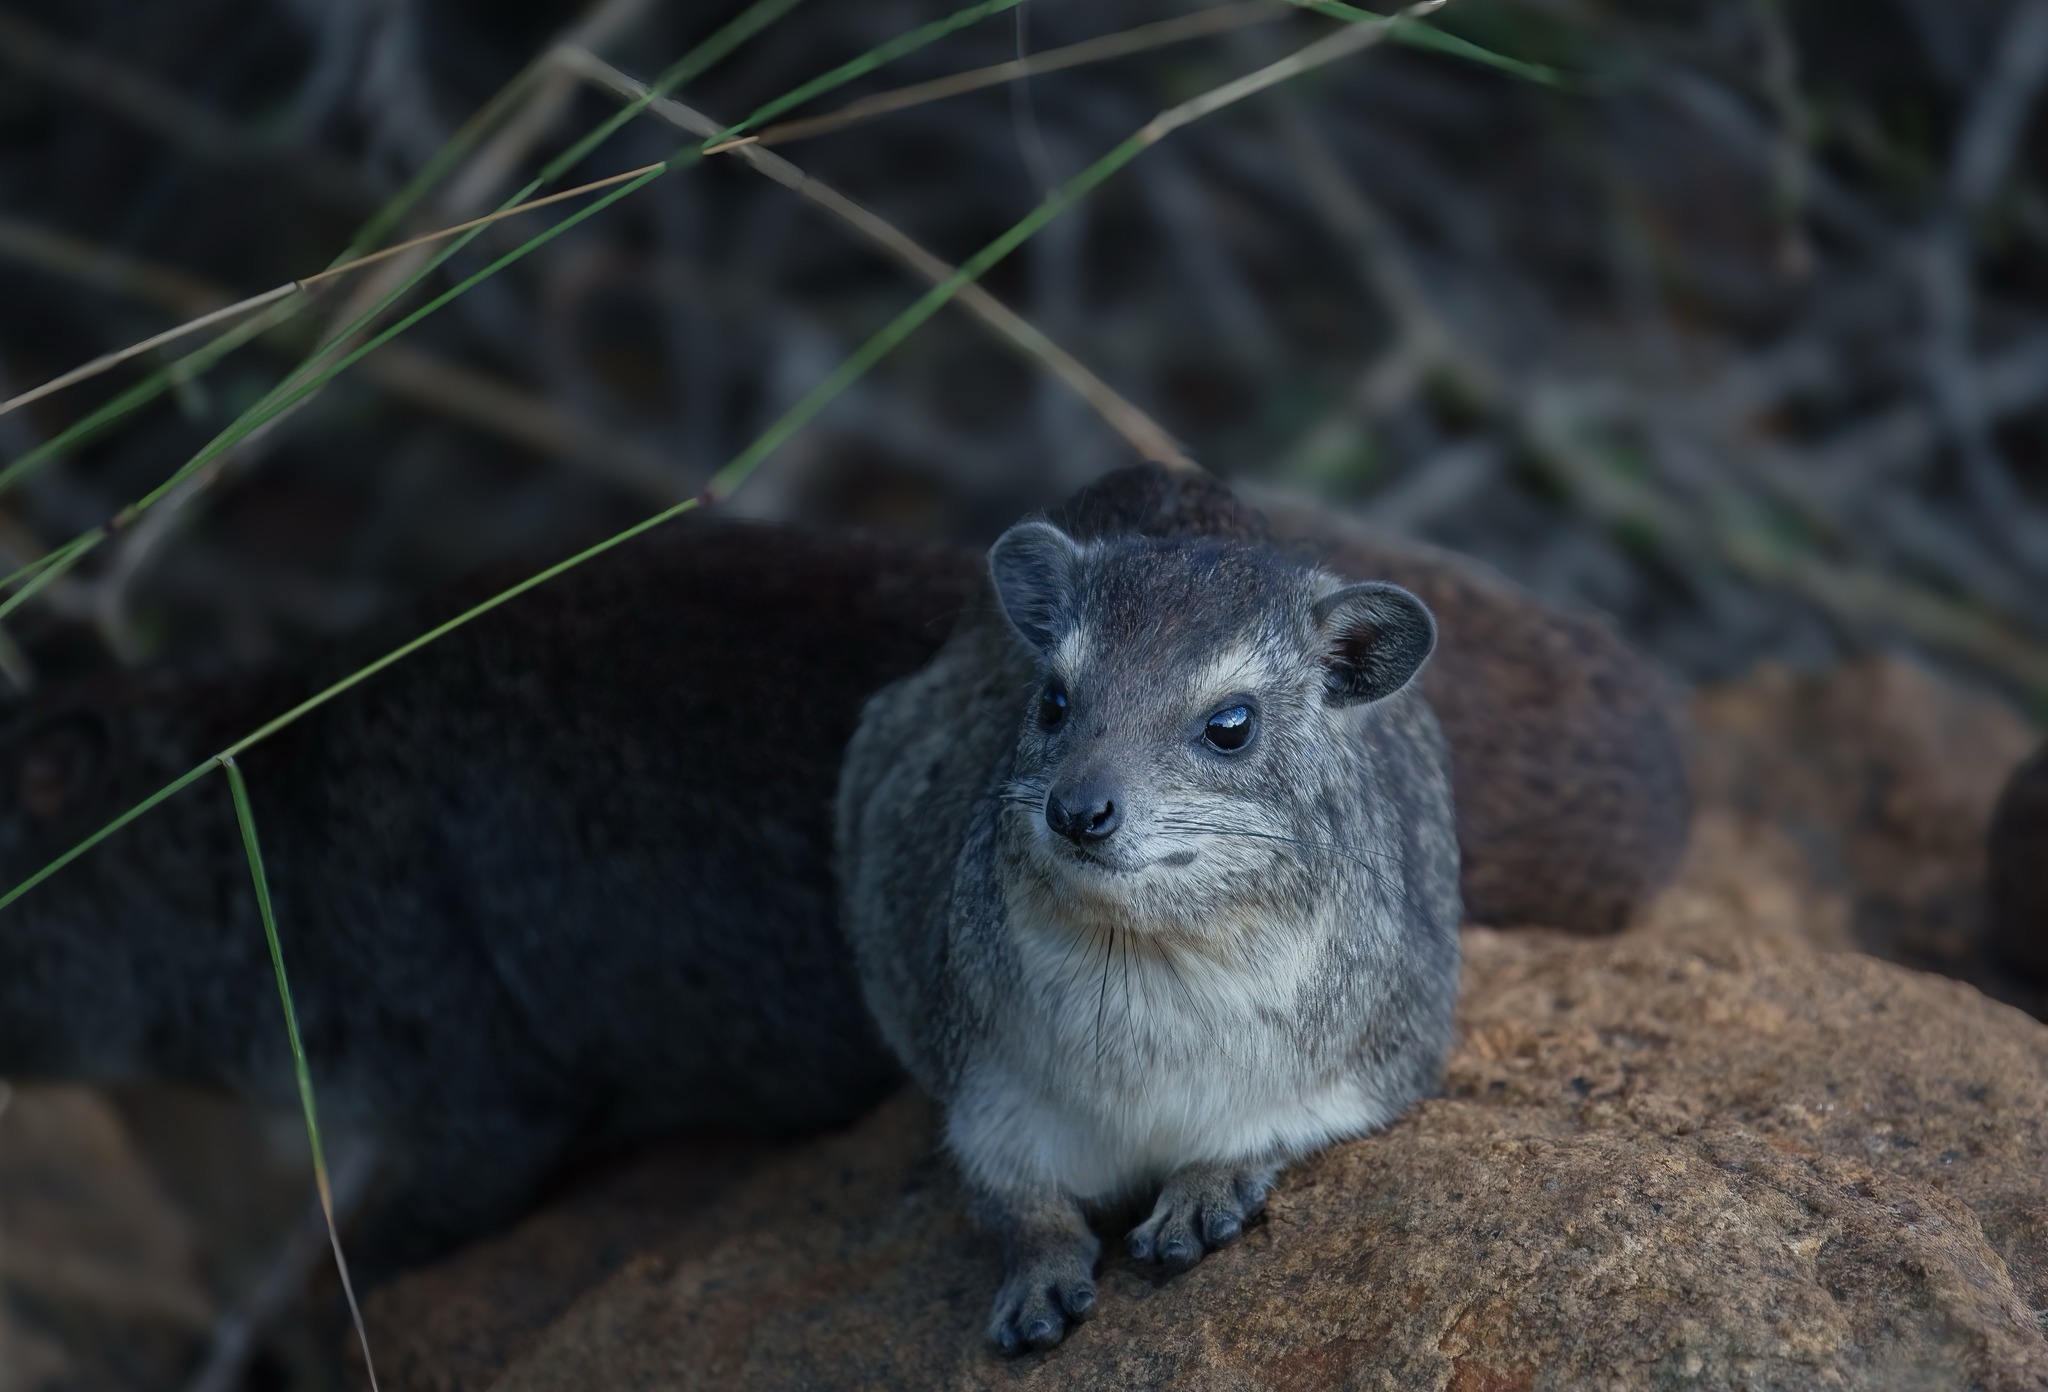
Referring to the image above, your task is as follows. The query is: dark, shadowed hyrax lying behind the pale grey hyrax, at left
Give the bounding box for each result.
[0,522,969,1267]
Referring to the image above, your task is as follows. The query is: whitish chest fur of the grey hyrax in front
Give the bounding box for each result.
[948,908,1397,1200]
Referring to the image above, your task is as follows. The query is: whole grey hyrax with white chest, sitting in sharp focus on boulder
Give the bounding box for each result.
[838,522,1458,1351]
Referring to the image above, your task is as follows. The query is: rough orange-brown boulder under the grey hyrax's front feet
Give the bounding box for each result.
[373,917,2048,1392]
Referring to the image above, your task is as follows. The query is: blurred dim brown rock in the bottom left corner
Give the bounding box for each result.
[0,1085,348,1392]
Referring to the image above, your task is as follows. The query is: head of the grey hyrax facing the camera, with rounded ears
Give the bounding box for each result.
[989,522,1436,927]
